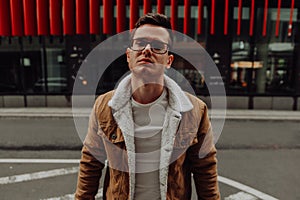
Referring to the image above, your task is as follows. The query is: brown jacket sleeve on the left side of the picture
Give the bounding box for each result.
[75,105,106,200]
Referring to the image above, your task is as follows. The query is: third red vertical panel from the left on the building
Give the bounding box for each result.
[23,0,37,36]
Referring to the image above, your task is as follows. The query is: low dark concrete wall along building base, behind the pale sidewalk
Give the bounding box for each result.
[0,95,300,110]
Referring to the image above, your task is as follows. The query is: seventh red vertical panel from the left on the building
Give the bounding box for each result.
[76,0,88,34]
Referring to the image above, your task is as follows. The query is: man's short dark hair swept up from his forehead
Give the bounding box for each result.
[131,13,173,48]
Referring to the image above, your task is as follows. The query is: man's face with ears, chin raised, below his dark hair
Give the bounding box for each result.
[126,24,174,78]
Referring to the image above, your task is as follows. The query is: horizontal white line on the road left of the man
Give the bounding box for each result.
[0,158,79,164]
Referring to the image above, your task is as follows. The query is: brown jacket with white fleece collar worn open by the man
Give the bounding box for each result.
[75,77,220,200]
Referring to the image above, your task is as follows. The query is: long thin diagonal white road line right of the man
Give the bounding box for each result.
[218,176,278,200]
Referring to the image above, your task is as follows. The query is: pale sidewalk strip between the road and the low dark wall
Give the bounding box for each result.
[0,107,300,121]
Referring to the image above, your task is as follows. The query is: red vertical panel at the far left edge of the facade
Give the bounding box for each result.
[0,0,11,36]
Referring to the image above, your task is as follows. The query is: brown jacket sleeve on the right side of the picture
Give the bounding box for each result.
[187,105,220,200]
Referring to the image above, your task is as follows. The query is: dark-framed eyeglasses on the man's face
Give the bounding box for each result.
[130,39,169,54]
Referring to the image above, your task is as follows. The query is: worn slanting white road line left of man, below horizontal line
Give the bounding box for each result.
[0,167,78,185]
